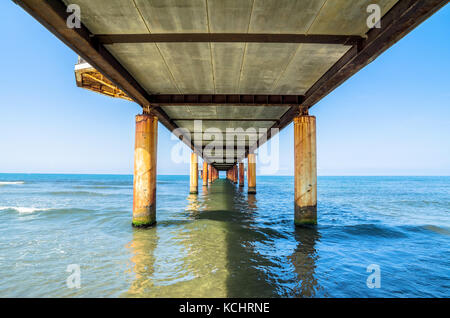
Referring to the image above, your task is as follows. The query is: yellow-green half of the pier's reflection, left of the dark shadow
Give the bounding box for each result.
[125,181,230,298]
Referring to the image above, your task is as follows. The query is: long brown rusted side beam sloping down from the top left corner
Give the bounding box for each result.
[14,0,202,157]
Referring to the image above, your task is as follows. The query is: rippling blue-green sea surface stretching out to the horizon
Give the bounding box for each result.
[0,174,450,297]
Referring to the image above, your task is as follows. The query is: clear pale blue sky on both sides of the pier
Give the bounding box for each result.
[0,1,450,175]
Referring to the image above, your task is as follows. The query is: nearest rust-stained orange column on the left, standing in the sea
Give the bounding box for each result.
[132,114,158,227]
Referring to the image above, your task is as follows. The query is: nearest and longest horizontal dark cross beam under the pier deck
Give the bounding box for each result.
[95,33,362,45]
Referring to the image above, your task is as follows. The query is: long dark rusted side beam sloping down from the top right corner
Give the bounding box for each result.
[302,0,448,108]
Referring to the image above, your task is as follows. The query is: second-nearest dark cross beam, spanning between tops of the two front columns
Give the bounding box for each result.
[150,94,304,106]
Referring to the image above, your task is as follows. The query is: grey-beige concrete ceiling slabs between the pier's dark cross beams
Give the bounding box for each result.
[64,0,398,163]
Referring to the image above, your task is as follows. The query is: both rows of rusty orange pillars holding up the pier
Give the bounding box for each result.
[132,114,317,227]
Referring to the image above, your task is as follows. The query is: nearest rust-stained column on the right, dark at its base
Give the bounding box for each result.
[294,115,317,225]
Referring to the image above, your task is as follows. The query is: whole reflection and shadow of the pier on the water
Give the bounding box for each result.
[125,180,319,298]
